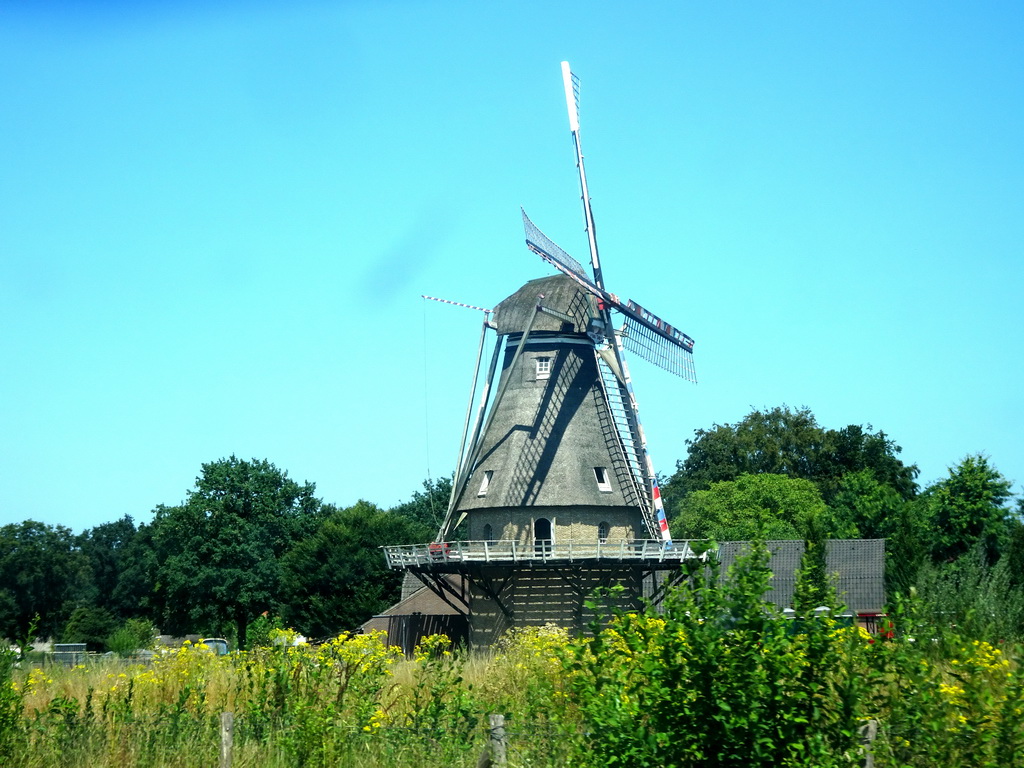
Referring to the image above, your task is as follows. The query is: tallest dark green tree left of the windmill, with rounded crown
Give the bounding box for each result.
[153,456,321,647]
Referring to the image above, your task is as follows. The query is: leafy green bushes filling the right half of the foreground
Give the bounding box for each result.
[564,547,1024,768]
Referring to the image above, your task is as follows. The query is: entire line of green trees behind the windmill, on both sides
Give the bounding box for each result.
[0,406,1024,650]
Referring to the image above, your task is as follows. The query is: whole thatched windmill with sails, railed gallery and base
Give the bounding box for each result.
[385,61,695,645]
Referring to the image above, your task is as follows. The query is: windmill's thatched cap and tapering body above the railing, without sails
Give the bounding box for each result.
[457,275,647,545]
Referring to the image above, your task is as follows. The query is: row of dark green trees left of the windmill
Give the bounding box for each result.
[0,456,451,650]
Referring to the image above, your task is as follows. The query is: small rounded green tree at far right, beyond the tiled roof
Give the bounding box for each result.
[928,454,1013,564]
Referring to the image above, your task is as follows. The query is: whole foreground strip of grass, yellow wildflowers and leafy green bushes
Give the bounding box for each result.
[0,562,1024,768]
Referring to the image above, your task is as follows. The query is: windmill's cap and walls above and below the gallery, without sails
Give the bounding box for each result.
[432,275,649,646]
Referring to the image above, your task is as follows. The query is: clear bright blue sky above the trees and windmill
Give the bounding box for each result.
[0,0,1024,530]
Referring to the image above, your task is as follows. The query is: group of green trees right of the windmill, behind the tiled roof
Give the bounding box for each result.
[663,406,1024,639]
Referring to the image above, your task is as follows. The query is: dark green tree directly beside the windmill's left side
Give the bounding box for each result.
[281,501,434,637]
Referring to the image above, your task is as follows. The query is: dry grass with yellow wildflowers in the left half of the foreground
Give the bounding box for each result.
[0,630,566,768]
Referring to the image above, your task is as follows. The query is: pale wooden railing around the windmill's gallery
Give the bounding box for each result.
[383,539,696,569]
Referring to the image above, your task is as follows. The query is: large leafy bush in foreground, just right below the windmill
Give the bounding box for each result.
[567,545,861,768]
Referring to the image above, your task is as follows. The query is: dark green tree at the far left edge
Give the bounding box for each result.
[0,520,88,639]
